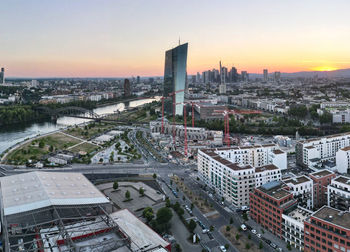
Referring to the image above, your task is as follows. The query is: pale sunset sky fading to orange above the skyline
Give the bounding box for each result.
[0,0,350,77]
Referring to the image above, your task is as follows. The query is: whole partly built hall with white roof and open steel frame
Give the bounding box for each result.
[0,172,168,252]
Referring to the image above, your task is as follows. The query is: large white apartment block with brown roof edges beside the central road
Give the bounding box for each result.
[198,149,281,207]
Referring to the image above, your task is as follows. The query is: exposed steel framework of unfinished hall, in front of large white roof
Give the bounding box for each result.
[2,204,131,252]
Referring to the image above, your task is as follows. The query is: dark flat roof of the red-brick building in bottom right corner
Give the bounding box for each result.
[312,206,350,230]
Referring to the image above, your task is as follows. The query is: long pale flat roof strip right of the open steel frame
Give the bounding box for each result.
[110,209,169,251]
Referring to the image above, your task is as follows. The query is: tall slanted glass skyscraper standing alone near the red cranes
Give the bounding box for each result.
[163,43,188,115]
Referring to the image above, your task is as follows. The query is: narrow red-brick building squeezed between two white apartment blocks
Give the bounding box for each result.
[309,170,336,208]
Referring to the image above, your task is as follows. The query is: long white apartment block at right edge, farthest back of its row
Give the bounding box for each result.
[295,132,350,167]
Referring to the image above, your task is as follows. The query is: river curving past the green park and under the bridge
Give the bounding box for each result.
[0,97,160,154]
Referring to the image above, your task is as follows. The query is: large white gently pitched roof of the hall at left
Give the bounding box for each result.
[0,171,109,215]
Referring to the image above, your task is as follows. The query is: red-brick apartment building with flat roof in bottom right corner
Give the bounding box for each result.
[304,206,350,252]
